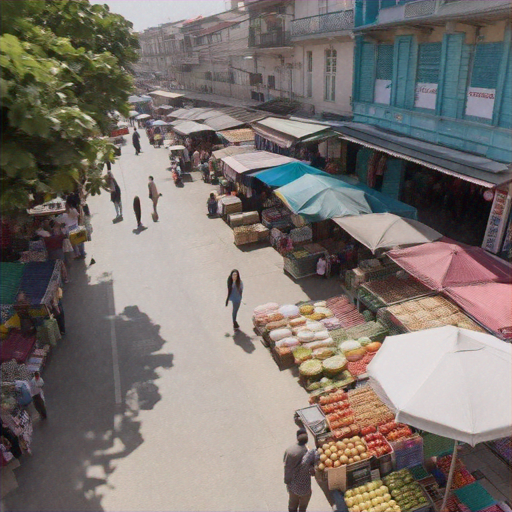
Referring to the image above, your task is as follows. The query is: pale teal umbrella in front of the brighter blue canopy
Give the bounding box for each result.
[275,173,372,222]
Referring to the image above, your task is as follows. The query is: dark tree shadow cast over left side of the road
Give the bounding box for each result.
[4,266,173,512]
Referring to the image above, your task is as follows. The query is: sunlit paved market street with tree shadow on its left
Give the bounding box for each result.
[5,136,337,512]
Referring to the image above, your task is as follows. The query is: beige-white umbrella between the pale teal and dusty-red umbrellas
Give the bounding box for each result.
[333,213,443,252]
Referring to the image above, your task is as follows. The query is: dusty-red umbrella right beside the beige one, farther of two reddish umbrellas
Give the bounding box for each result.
[387,237,512,291]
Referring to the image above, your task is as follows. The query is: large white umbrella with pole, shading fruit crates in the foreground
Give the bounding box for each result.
[367,326,512,509]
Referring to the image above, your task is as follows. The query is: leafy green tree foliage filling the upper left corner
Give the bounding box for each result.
[0,0,138,210]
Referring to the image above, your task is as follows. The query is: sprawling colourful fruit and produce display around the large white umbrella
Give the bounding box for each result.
[253,294,509,512]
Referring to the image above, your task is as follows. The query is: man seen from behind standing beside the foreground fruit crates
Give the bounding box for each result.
[283,428,317,512]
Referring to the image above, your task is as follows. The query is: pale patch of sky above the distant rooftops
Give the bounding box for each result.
[91,0,229,32]
